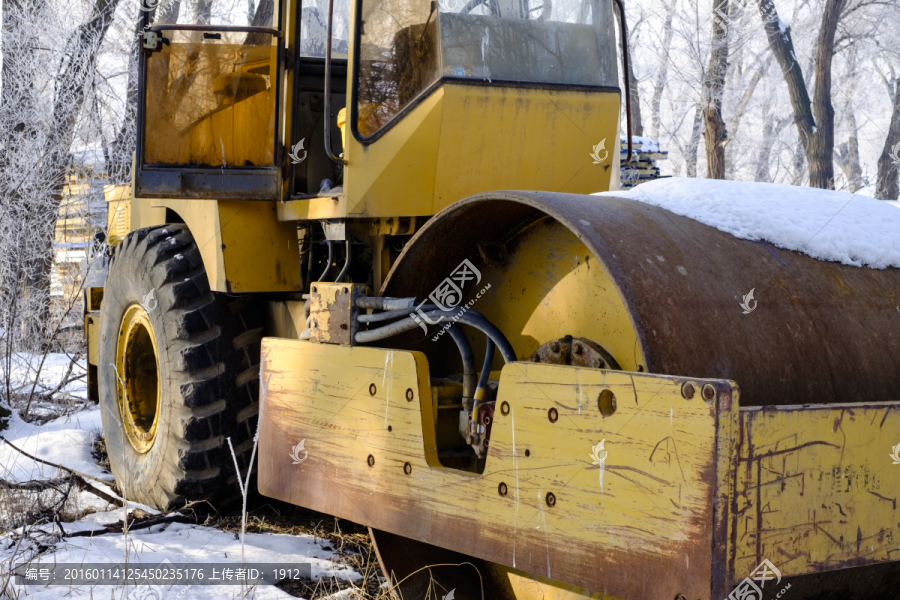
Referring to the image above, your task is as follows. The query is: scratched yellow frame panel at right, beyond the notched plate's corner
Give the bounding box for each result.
[732,402,900,580]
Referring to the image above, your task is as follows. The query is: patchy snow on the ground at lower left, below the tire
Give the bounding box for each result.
[0,355,363,600]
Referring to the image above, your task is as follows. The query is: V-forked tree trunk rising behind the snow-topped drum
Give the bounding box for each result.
[759,0,846,189]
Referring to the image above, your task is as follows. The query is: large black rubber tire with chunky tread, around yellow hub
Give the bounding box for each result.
[98,224,263,509]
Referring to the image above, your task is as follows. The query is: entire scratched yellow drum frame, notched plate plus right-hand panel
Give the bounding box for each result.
[259,338,900,599]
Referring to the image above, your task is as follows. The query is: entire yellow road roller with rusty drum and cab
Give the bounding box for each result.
[84,0,900,600]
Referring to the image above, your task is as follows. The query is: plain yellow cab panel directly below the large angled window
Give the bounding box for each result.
[342,83,620,218]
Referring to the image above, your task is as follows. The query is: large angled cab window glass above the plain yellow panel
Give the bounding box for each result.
[357,0,618,137]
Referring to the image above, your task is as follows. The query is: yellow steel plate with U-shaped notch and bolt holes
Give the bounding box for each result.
[259,338,735,598]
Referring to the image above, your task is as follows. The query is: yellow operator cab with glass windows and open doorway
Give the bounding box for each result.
[135,0,621,204]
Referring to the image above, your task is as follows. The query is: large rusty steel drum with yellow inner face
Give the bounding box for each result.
[373,191,900,598]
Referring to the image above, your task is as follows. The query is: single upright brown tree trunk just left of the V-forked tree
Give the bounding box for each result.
[703,0,730,179]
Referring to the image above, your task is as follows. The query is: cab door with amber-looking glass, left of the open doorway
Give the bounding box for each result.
[135,0,283,200]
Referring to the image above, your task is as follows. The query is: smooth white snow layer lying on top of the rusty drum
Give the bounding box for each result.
[596,177,900,269]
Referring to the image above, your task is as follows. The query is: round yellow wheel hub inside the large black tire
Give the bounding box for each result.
[116,304,160,453]
